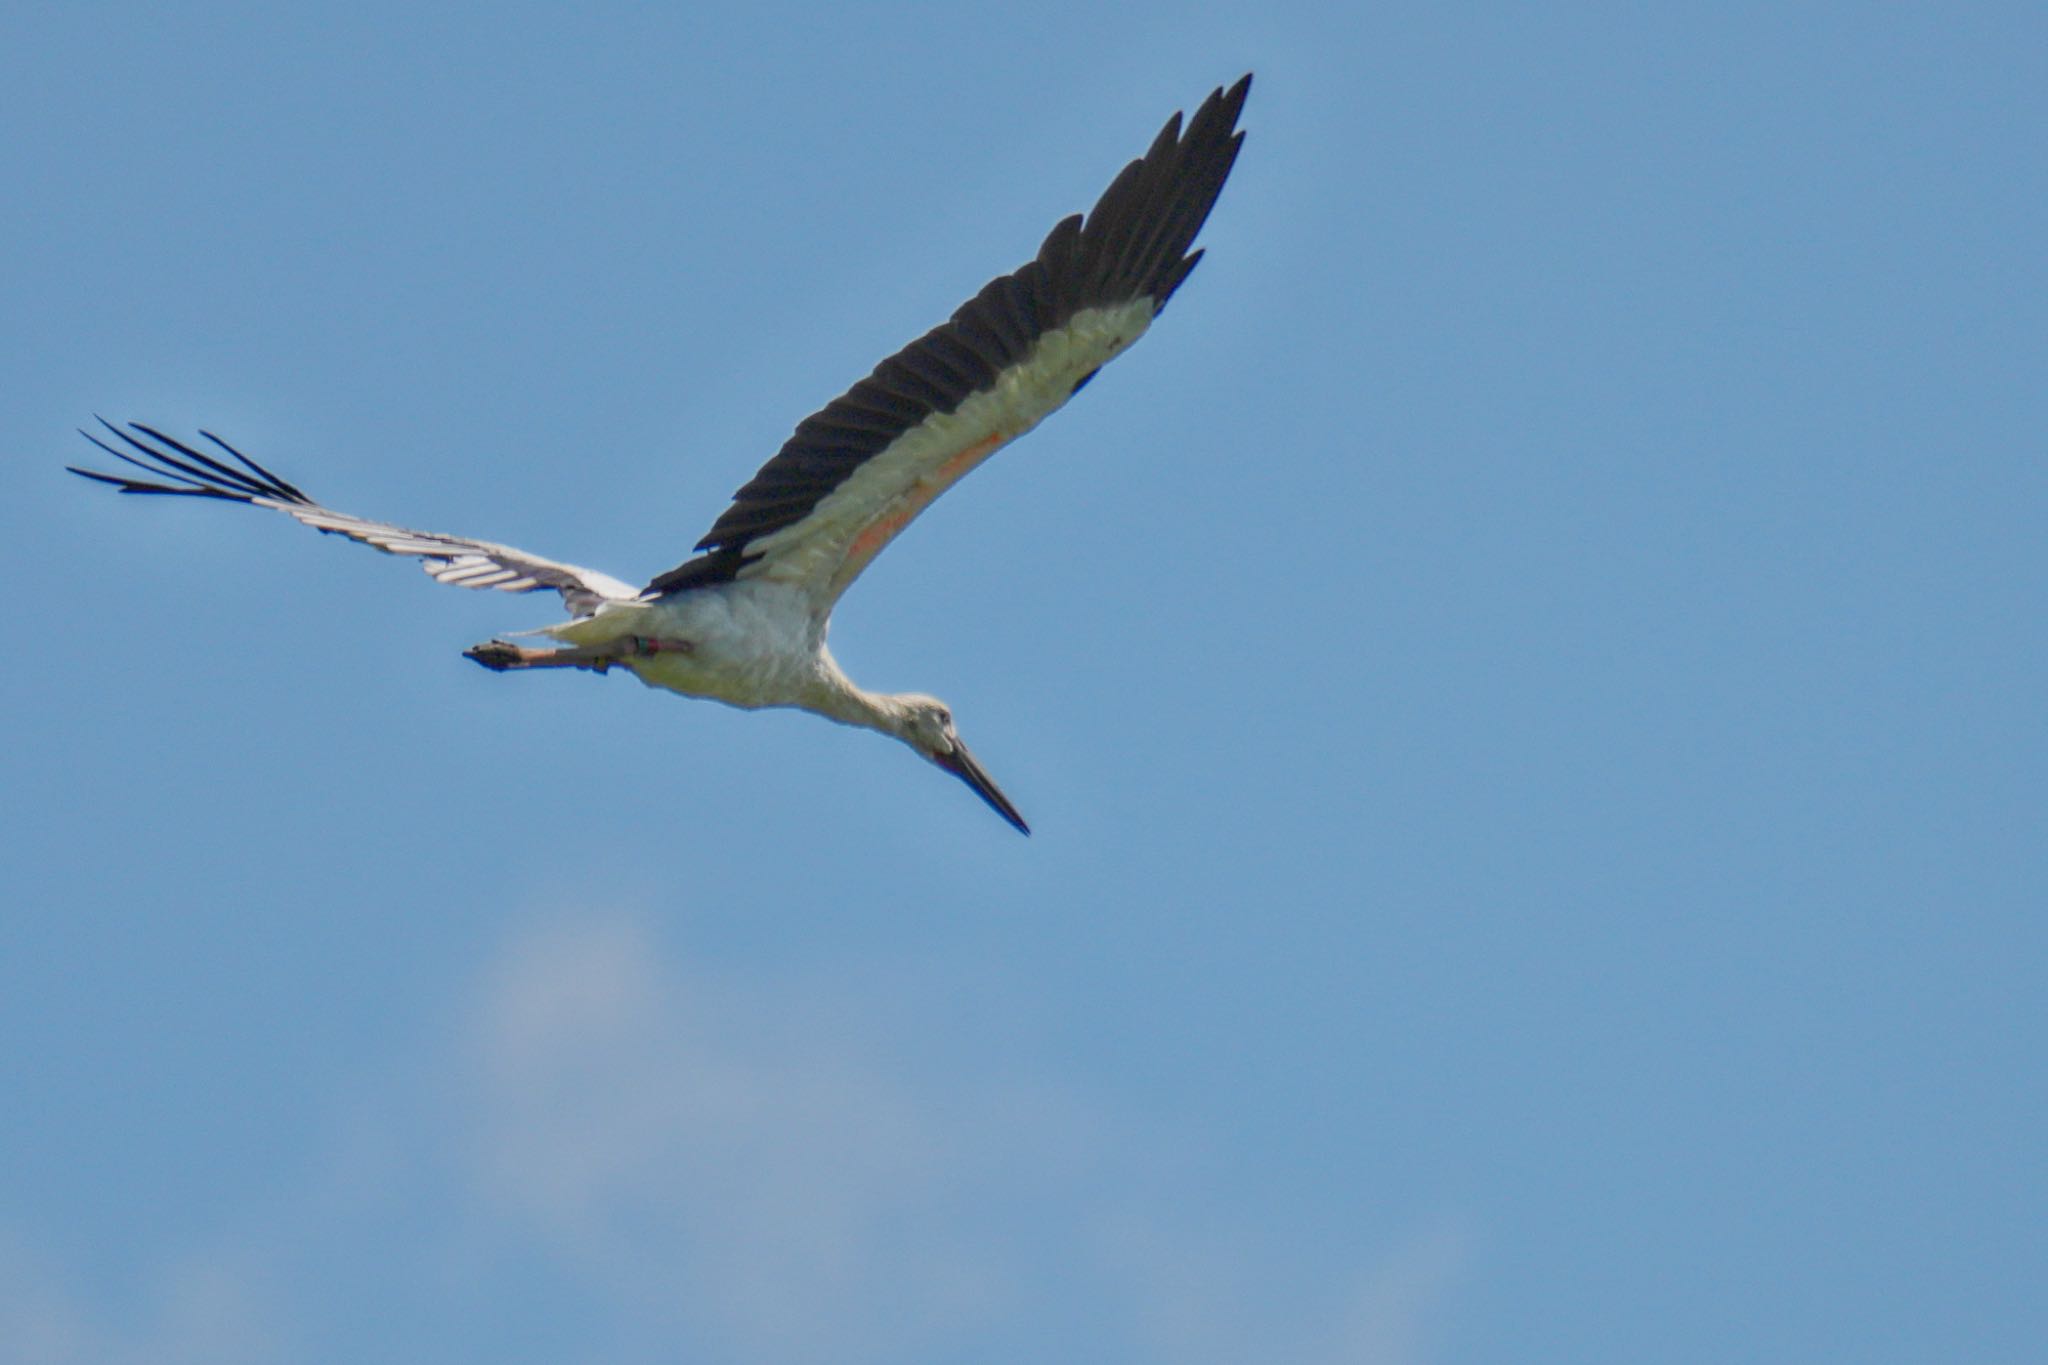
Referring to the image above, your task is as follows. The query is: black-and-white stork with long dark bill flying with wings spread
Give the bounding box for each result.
[72,76,1251,835]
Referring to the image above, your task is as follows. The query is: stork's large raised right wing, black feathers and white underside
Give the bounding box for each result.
[647,76,1251,606]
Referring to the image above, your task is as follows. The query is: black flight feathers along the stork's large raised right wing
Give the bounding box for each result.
[647,76,1251,593]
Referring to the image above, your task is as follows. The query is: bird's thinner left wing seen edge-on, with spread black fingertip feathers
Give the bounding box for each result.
[72,417,639,616]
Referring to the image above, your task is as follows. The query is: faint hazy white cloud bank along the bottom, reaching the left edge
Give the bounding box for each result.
[0,915,1468,1365]
